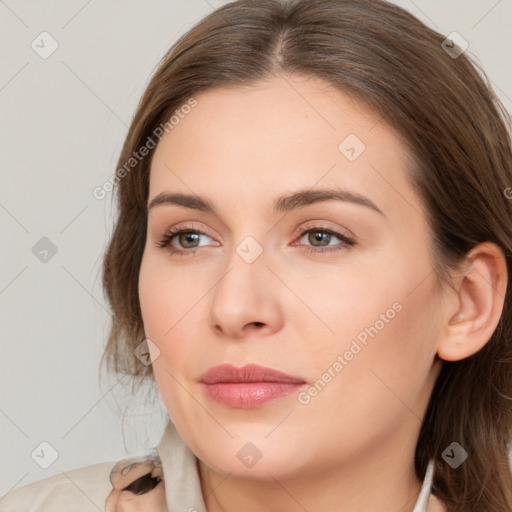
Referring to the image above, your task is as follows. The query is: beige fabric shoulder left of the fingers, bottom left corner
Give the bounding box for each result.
[0,462,116,512]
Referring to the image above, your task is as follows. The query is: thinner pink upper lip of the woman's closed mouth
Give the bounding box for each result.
[200,364,305,384]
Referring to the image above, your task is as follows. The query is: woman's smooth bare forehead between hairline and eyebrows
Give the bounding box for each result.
[150,75,415,220]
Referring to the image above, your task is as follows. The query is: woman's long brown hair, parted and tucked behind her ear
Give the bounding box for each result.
[102,0,512,512]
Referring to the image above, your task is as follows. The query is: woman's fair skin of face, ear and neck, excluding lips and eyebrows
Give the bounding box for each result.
[139,75,506,512]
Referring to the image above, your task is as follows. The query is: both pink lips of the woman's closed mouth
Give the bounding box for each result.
[201,364,306,409]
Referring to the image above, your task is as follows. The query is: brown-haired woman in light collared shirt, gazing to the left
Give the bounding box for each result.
[0,0,512,512]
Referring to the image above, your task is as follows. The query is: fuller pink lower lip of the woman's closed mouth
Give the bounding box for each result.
[203,382,305,409]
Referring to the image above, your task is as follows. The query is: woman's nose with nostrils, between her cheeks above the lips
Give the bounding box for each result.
[208,244,283,340]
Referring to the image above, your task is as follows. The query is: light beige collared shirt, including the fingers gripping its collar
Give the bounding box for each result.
[0,422,443,512]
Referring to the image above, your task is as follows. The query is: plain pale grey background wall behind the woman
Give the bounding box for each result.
[0,0,512,495]
